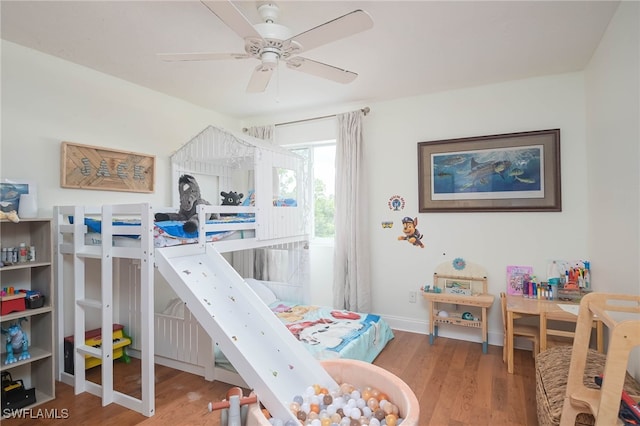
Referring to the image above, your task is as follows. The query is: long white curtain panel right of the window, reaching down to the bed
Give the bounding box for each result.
[333,110,371,312]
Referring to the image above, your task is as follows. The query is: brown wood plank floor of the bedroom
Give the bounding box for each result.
[2,331,538,426]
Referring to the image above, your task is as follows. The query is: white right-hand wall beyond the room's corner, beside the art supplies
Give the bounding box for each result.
[585,2,640,378]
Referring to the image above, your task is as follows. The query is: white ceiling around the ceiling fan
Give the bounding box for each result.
[0,0,618,118]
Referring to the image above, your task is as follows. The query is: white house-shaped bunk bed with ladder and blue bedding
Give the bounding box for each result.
[54,126,393,416]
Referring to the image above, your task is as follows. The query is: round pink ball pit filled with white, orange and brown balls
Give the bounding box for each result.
[247,359,420,426]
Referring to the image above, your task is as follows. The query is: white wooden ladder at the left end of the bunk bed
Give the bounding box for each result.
[60,203,155,417]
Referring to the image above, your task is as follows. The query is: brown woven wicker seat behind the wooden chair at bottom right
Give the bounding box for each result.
[536,346,640,426]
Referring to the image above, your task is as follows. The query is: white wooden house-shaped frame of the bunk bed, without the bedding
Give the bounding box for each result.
[54,126,308,416]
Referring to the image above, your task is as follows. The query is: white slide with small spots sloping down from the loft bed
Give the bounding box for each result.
[155,244,338,423]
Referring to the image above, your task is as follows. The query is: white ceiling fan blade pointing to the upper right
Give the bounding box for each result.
[289,9,373,52]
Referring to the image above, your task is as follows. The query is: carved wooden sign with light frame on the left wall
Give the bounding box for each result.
[60,142,156,192]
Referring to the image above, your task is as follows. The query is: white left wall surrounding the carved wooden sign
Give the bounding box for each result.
[0,41,238,216]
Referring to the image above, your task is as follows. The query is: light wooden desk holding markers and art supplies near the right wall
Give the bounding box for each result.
[507,296,604,374]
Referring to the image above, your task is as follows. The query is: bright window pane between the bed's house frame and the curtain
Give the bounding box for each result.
[291,140,336,242]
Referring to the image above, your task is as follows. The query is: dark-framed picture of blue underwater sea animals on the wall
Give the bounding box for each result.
[418,129,562,213]
